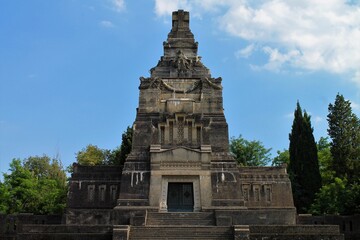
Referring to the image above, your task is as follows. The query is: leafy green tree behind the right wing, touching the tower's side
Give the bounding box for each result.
[230,135,271,166]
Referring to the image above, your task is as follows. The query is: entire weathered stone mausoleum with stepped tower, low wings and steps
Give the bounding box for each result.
[13,10,343,240]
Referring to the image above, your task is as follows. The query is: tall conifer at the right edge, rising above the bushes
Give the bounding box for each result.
[327,93,360,183]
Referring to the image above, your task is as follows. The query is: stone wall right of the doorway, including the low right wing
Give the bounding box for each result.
[211,165,294,209]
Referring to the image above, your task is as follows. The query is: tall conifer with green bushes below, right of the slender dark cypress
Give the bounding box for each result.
[311,94,360,214]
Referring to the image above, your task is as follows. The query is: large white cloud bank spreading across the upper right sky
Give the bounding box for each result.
[155,0,360,86]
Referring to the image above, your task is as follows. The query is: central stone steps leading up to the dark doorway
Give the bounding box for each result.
[129,212,234,240]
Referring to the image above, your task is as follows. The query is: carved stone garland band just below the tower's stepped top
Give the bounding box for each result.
[139,77,222,93]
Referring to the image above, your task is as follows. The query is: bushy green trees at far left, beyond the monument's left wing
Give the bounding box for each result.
[0,155,67,214]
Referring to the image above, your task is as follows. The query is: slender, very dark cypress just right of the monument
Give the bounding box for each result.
[288,102,321,213]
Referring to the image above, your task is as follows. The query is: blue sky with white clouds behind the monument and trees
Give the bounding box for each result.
[0,0,360,172]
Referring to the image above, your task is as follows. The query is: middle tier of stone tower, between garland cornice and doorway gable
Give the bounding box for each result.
[133,78,229,152]
